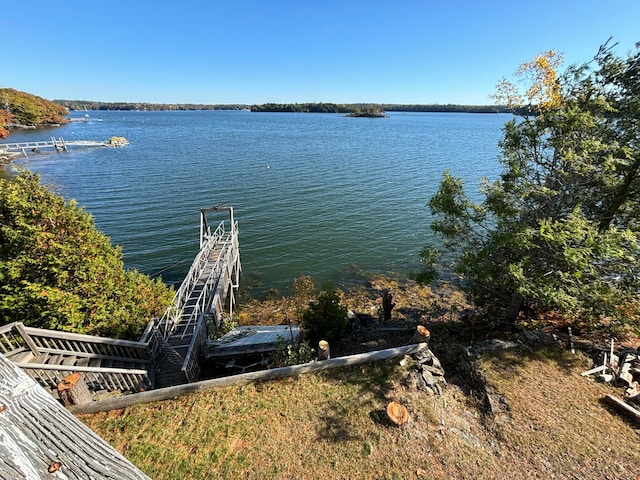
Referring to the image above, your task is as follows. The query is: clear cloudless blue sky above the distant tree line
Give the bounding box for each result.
[0,0,640,105]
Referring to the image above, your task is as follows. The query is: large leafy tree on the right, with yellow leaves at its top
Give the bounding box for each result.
[427,44,640,327]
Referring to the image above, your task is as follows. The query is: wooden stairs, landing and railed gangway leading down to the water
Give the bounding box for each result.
[0,205,241,393]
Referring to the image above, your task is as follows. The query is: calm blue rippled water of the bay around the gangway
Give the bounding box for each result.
[2,111,509,295]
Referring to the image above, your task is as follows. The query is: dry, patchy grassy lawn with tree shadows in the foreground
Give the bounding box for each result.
[81,350,640,480]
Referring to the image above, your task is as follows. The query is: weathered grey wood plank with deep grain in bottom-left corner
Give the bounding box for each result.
[0,355,149,480]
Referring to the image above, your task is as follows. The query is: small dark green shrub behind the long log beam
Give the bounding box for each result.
[302,284,348,345]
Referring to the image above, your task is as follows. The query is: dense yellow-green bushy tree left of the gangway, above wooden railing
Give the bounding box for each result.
[0,172,173,339]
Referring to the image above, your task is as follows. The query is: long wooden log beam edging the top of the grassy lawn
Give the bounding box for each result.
[69,343,428,414]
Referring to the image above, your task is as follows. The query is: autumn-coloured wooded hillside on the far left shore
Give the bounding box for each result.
[0,88,69,138]
